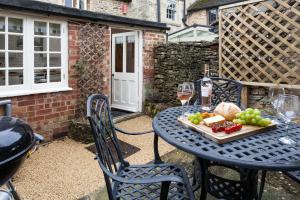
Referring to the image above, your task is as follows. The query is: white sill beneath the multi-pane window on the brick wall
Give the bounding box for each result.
[0,87,73,98]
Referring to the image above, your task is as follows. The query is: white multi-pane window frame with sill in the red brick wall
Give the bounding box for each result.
[0,12,72,98]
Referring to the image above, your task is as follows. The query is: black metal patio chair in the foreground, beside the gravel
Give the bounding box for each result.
[87,94,195,200]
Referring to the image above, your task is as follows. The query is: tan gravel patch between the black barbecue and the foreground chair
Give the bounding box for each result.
[15,139,103,200]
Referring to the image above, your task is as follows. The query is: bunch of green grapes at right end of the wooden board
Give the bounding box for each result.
[233,108,272,127]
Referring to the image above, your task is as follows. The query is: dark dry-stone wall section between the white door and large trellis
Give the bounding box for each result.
[147,42,218,105]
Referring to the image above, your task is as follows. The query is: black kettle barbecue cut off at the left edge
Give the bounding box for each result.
[0,100,43,200]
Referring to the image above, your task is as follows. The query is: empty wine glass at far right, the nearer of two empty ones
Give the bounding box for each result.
[277,95,299,145]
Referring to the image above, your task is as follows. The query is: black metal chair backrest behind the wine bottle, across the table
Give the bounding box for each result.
[195,77,243,107]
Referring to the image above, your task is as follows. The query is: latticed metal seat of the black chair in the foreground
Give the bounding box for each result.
[114,164,194,200]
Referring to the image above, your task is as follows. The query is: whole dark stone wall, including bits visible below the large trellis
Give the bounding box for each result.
[145,42,300,115]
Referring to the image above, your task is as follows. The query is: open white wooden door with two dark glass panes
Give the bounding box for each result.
[112,32,139,112]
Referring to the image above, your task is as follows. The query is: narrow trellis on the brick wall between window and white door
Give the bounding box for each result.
[77,23,107,117]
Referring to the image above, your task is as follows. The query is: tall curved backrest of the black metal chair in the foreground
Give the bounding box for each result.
[87,94,128,197]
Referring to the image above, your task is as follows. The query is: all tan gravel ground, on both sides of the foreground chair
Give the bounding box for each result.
[14,116,174,200]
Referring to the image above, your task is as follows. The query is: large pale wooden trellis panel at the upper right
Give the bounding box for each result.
[219,0,300,89]
